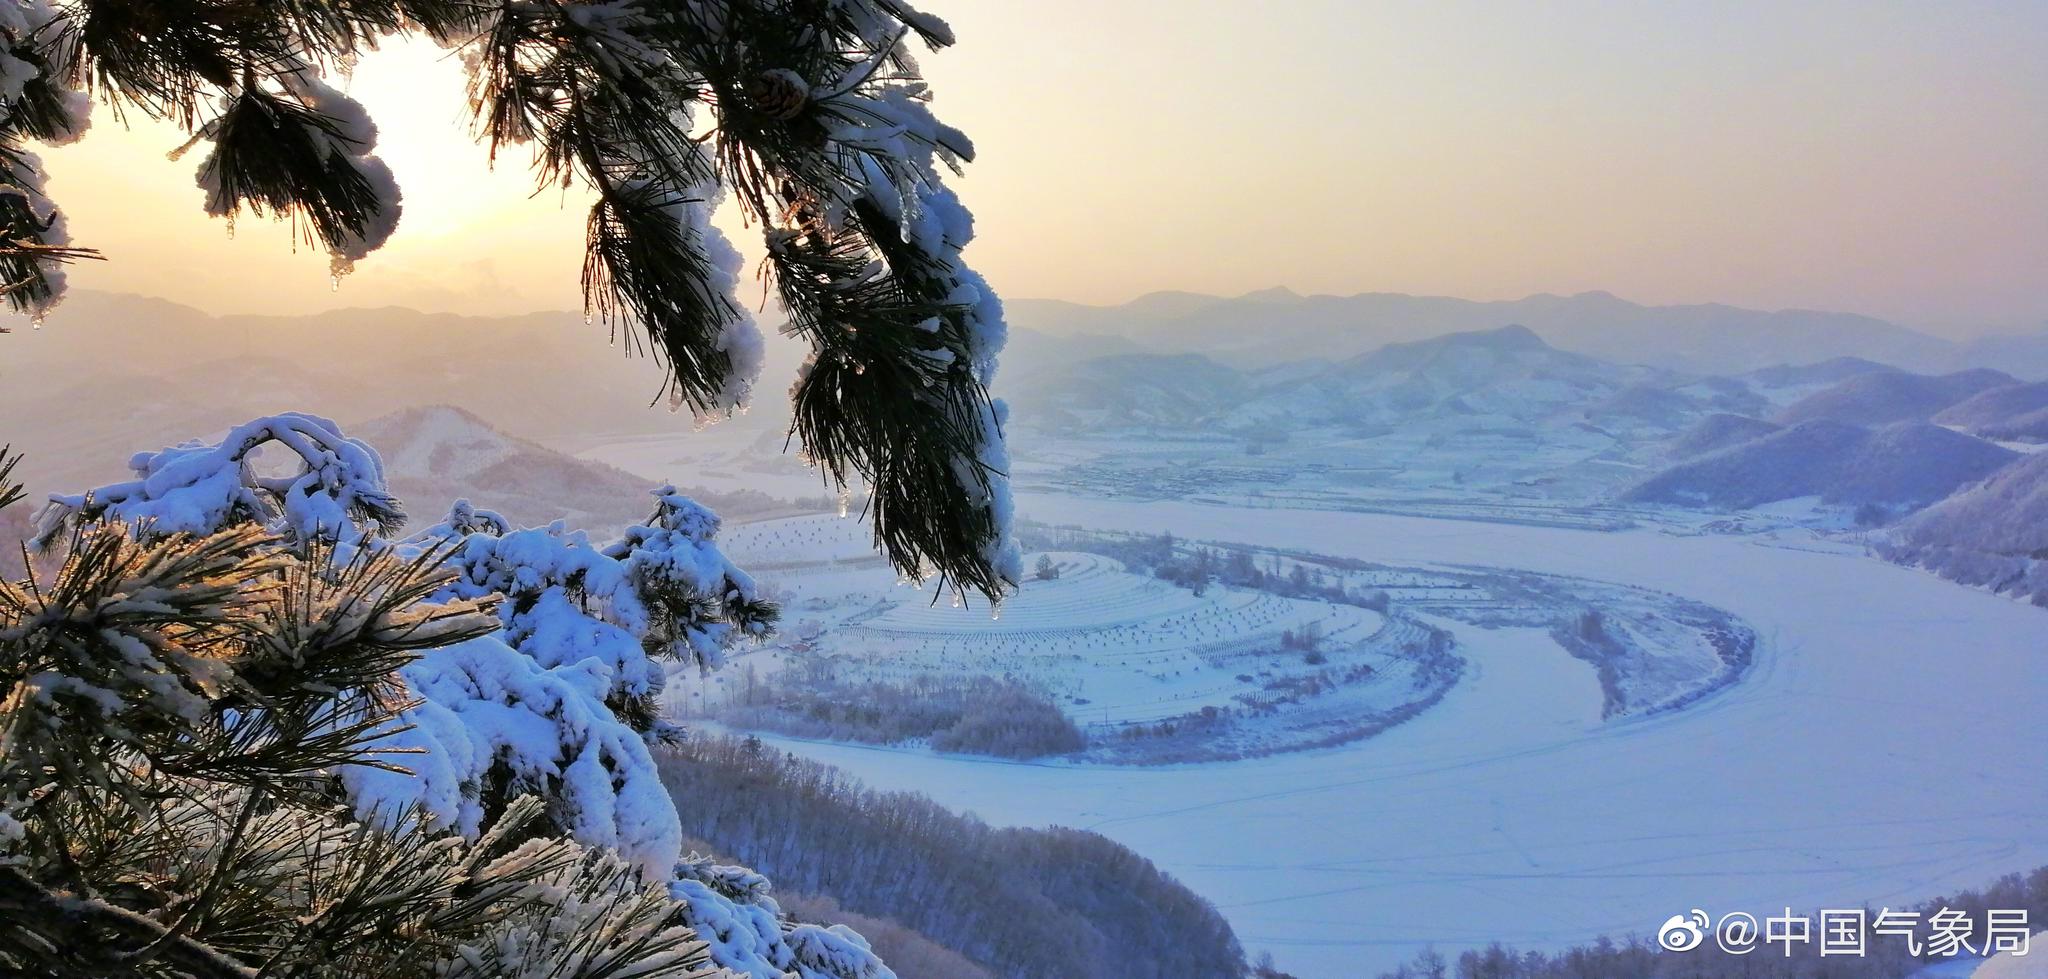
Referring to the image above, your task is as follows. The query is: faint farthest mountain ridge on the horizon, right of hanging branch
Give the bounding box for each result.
[1006,289,2048,377]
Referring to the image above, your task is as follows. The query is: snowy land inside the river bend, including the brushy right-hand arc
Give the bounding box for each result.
[688,514,1755,764]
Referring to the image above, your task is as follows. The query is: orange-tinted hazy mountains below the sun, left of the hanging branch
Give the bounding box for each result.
[0,291,749,493]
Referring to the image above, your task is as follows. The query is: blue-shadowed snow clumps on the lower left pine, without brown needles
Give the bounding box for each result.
[43,414,806,979]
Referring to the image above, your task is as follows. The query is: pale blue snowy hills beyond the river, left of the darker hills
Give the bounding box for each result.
[1014,326,1949,506]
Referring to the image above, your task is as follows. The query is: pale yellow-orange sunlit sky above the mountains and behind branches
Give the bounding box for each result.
[28,0,2048,334]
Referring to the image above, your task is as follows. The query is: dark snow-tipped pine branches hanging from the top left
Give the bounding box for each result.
[0,0,1020,598]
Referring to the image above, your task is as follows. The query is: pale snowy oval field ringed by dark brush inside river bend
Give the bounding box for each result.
[688,516,1456,764]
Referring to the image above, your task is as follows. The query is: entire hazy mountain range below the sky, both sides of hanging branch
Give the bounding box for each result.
[0,291,2048,526]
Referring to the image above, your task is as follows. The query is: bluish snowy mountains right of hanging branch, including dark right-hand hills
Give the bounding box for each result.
[995,313,2048,518]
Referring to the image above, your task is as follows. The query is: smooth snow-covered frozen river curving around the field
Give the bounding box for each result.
[757,496,2048,977]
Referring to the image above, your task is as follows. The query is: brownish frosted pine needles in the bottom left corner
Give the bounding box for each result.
[0,446,733,979]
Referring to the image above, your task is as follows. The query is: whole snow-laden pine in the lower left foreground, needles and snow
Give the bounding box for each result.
[0,414,893,979]
